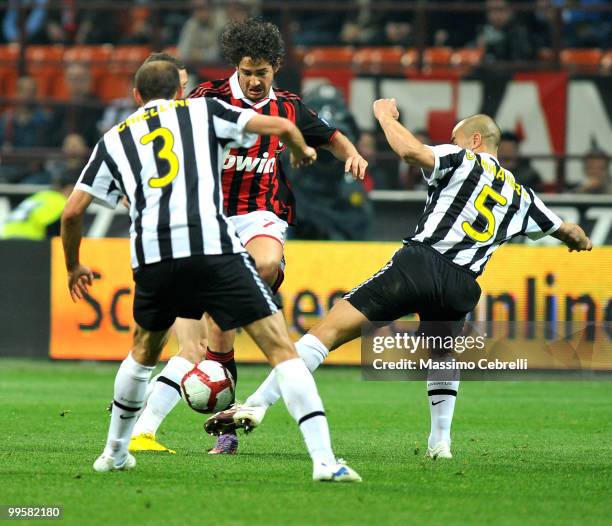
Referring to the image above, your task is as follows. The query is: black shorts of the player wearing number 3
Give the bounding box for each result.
[134,252,278,331]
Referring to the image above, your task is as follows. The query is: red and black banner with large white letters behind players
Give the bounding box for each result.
[304,68,612,184]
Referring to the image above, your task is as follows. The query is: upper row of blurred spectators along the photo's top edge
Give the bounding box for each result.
[0,0,612,56]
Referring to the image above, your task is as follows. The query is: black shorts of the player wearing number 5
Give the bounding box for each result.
[344,241,481,333]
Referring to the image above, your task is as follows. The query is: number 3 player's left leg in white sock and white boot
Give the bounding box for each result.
[93,325,168,472]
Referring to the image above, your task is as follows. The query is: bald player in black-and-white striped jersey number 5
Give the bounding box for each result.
[206,99,592,458]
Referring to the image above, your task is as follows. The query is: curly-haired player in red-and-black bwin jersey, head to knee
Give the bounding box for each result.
[190,19,367,288]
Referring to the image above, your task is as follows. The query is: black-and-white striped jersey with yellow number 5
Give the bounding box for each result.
[408,144,562,275]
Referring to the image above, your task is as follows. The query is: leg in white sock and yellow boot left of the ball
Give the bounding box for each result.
[129,317,207,453]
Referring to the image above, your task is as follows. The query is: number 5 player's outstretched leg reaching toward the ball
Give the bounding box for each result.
[205,300,367,434]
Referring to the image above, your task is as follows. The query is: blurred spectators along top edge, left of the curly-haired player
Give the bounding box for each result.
[0,0,251,57]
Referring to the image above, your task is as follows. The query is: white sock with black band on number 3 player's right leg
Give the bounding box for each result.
[274,358,336,465]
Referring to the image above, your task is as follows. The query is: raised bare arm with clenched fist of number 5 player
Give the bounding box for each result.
[373,99,435,170]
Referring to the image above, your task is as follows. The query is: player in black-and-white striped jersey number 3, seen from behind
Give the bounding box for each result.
[62,61,361,482]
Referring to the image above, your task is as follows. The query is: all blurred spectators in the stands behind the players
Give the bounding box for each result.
[0,0,612,193]
